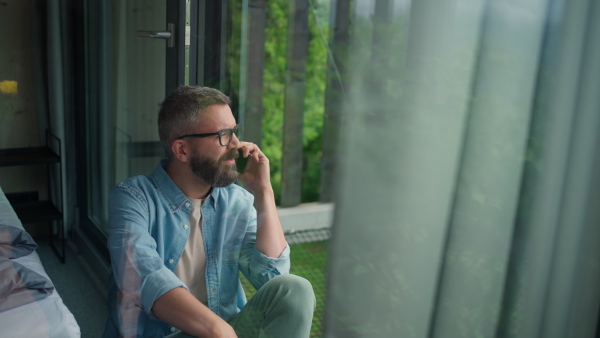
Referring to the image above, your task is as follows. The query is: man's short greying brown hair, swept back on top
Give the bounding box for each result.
[158,86,231,160]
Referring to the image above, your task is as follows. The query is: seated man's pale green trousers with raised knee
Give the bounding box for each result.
[168,274,316,338]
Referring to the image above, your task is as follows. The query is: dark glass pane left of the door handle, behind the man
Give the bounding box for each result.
[87,0,166,232]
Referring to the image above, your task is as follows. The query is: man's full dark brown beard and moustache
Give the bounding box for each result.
[190,149,239,188]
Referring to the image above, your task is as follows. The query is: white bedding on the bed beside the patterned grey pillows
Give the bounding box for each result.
[0,188,81,338]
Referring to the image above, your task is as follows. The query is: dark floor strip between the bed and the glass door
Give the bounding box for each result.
[35,238,108,338]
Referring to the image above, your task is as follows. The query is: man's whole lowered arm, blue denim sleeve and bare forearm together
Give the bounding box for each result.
[108,187,236,337]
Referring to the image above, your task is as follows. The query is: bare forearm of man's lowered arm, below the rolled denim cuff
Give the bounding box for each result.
[152,288,237,337]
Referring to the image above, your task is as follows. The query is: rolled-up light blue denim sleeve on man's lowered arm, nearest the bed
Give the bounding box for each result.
[108,185,187,325]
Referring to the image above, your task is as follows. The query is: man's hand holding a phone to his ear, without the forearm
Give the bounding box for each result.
[240,142,273,193]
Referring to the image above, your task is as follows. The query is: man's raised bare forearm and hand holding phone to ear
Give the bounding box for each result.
[241,142,286,258]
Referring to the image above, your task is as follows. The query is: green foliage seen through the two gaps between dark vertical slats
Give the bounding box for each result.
[262,0,329,202]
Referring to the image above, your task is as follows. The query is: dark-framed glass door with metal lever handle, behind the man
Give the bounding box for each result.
[79,0,237,240]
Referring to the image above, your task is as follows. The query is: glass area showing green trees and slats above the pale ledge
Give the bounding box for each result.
[227,0,330,204]
